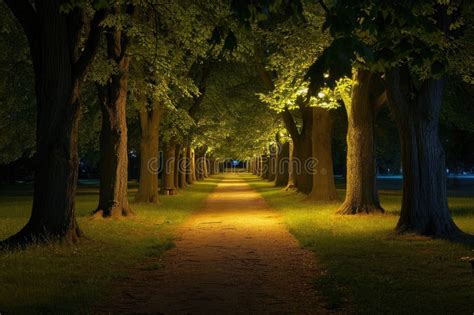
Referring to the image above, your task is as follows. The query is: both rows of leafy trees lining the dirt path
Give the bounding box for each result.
[0,0,472,247]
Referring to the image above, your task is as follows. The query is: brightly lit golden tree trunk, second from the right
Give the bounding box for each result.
[338,69,384,214]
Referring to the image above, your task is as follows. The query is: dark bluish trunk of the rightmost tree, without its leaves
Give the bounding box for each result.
[385,69,474,242]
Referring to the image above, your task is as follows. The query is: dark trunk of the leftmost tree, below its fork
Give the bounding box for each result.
[0,55,82,244]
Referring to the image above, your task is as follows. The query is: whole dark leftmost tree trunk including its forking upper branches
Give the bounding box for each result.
[0,0,104,249]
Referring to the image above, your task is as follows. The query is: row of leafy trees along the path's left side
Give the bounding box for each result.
[0,0,275,252]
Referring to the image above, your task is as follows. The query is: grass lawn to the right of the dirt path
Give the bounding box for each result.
[246,175,474,314]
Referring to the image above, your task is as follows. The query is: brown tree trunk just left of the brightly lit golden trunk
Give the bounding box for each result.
[310,107,337,202]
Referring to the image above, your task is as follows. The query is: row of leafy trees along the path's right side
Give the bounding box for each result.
[242,1,472,241]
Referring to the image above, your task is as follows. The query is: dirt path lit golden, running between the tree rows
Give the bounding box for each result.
[97,174,325,314]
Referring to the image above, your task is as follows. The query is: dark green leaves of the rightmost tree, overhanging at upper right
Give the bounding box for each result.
[308,0,467,81]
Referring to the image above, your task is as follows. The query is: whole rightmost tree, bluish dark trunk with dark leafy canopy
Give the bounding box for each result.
[312,0,472,240]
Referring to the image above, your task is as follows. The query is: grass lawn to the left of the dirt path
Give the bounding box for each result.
[0,177,219,313]
